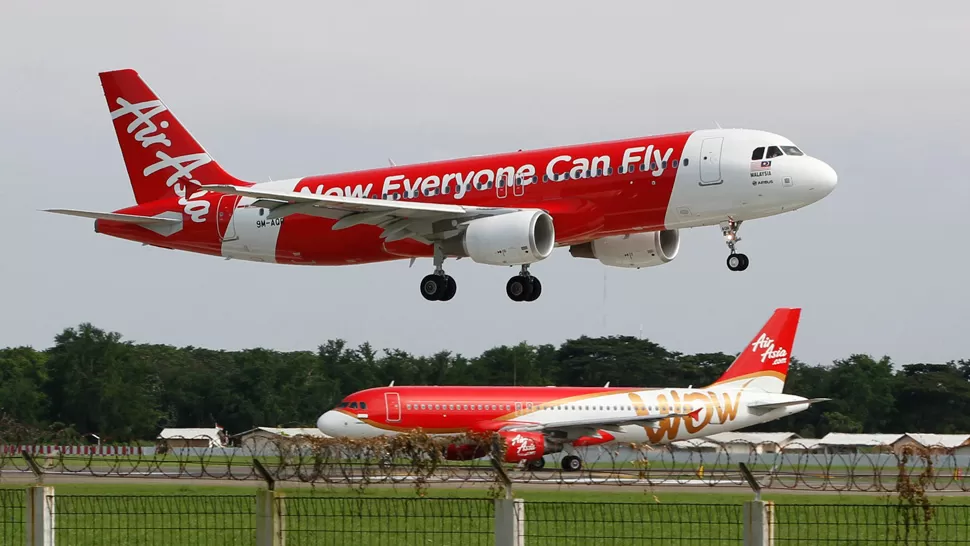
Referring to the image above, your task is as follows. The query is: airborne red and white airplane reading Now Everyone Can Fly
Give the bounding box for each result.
[48,69,837,301]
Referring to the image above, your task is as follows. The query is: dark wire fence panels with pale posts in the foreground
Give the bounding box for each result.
[0,486,970,546]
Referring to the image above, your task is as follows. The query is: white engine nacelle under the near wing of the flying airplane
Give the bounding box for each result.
[442,210,556,265]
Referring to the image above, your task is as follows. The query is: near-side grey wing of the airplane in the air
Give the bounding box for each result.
[196,184,523,243]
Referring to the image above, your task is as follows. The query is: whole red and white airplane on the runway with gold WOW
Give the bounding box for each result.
[317,308,828,471]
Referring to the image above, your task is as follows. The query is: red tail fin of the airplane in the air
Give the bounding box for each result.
[99,69,246,204]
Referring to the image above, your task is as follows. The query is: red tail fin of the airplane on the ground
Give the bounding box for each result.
[714,308,802,393]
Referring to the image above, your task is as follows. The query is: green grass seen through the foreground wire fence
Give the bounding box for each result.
[0,481,970,546]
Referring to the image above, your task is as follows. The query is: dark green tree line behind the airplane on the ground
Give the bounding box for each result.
[0,323,970,442]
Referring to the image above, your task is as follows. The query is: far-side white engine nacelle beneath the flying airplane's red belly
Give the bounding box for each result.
[569,229,680,269]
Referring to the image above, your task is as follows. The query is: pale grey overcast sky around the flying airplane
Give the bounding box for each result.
[0,0,970,372]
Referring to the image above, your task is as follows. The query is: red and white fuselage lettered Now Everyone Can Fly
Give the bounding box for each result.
[95,129,836,265]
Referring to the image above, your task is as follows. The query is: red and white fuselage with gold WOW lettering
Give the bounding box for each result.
[317,386,809,447]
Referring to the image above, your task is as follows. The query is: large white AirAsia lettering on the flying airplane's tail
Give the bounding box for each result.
[111,97,212,223]
